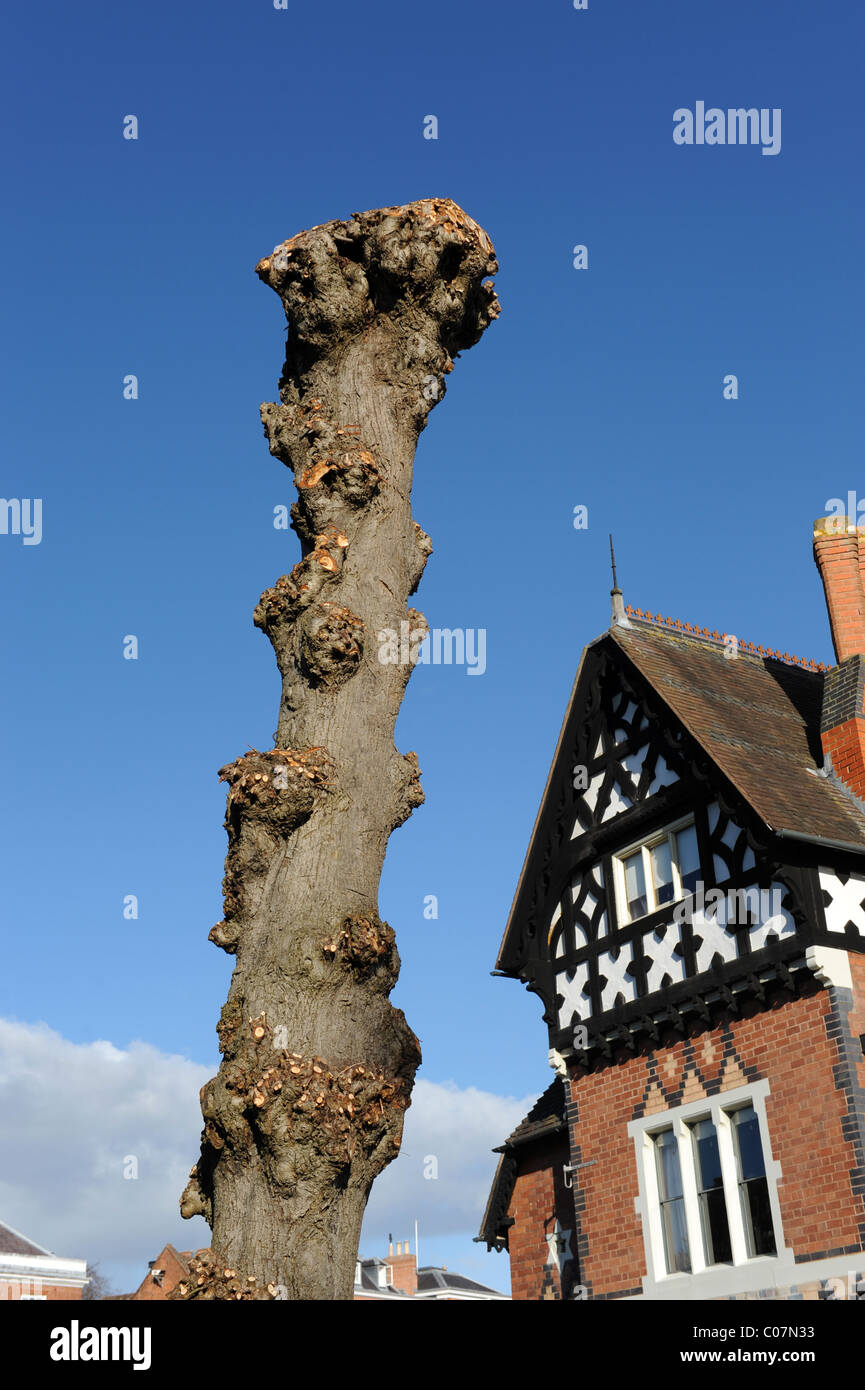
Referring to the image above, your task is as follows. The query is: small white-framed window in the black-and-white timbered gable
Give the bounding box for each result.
[613,817,700,926]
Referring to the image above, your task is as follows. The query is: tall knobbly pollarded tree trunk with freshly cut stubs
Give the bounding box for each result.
[179,199,498,1300]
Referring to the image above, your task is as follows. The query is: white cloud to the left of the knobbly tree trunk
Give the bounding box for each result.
[0,1019,211,1293]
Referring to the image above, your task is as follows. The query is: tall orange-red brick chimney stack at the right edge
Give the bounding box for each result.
[814,516,865,801]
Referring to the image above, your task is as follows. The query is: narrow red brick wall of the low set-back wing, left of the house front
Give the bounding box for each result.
[508,1134,576,1298]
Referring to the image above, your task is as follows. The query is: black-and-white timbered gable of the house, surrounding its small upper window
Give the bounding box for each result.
[496,631,865,1065]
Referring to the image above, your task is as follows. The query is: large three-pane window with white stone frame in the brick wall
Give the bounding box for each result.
[629,1081,793,1298]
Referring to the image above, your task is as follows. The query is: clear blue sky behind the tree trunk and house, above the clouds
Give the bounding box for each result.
[0,0,865,1283]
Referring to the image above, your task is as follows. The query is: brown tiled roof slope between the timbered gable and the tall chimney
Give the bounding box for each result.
[614,619,865,849]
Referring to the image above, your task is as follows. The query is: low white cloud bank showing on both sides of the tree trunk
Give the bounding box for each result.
[0,1019,535,1293]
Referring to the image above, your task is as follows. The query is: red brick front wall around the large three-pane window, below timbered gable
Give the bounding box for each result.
[570,973,865,1298]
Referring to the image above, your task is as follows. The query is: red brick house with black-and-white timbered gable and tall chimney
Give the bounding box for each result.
[481,518,865,1300]
